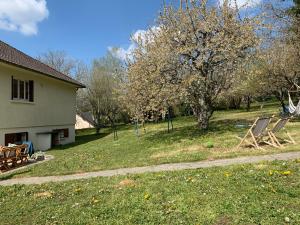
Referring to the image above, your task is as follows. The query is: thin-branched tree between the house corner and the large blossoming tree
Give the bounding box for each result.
[84,52,124,138]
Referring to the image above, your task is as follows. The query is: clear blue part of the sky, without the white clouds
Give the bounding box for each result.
[0,0,169,62]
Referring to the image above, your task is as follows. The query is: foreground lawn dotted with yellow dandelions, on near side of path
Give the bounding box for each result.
[0,159,300,225]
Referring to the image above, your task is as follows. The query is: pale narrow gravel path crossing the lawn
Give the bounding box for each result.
[0,152,300,186]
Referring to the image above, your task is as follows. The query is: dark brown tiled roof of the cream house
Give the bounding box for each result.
[0,40,85,88]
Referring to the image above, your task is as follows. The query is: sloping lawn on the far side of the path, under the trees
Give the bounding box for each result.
[0,103,300,179]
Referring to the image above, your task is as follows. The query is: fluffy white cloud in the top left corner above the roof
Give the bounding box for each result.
[0,0,49,35]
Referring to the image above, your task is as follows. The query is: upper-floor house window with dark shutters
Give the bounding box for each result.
[11,77,34,102]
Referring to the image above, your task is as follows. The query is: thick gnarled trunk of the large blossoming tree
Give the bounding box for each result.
[193,100,213,130]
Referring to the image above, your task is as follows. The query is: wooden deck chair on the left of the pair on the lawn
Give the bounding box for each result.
[237,117,273,149]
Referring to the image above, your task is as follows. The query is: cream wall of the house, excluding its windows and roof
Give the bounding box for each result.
[0,63,77,148]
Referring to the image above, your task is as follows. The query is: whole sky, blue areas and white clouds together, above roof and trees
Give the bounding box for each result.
[0,0,290,63]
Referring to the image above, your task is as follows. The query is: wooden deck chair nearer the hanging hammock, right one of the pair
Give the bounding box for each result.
[268,117,296,147]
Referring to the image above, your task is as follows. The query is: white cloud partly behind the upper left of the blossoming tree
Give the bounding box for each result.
[108,26,160,60]
